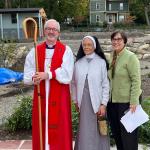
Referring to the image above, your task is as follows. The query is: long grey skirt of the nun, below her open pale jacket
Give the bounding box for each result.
[74,80,110,150]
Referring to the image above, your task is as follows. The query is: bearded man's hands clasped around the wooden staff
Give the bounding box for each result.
[33,72,48,85]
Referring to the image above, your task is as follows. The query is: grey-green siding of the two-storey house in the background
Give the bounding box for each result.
[90,0,129,24]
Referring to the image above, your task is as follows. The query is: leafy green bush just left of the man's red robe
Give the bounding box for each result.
[5,96,32,131]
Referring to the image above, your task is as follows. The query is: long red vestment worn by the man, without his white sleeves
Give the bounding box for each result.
[32,42,72,150]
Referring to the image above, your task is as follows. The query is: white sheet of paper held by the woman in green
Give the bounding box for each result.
[120,105,149,133]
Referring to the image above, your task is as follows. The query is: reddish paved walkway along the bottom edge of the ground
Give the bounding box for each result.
[0,140,150,150]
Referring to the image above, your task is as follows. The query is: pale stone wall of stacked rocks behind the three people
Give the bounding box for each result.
[2,32,150,72]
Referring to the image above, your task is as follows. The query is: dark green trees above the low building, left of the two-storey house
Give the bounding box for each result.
[0,0,89,22]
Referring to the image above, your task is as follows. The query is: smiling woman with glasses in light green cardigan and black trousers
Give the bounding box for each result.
[107,31,141,150]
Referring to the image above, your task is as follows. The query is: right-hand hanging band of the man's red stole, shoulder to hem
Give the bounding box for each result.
[48,42,65,146]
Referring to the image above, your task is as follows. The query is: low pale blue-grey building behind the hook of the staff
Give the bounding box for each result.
[0,8,46,40]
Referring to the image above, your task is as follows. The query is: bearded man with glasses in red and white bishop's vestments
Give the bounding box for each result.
[24,19,74,150]
